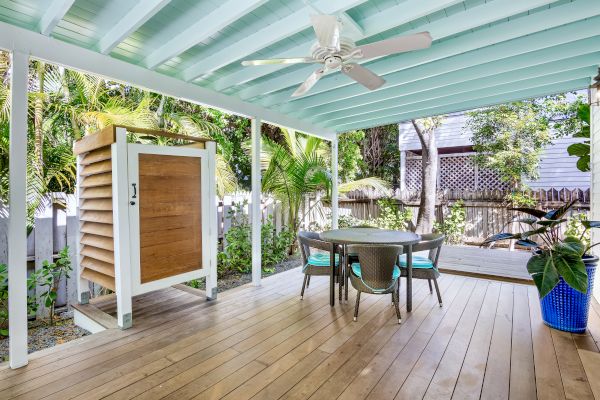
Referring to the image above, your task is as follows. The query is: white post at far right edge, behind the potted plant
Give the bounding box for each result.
[590,88,600,301]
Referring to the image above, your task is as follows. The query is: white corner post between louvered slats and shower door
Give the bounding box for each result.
[111,128,132,329]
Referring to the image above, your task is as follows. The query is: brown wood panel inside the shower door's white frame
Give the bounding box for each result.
[139,154,202,283]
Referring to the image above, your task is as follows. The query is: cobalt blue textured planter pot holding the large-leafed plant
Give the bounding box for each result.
[540,256,598,333]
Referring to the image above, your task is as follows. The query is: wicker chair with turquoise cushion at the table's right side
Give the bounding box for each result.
[400,233,445,307]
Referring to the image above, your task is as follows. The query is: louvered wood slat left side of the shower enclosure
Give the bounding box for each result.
[73,126,116,290]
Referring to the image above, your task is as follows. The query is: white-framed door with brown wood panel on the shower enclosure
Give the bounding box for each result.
[128,145,206,294]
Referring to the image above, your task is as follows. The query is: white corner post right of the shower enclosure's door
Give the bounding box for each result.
[206,142,219,300]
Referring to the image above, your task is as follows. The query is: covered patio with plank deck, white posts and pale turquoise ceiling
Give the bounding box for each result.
[0,0,600,399]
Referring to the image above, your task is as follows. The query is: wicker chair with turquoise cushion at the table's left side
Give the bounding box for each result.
[298,231,343,299]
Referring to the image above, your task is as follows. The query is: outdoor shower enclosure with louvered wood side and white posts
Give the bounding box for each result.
[74,125,217,330]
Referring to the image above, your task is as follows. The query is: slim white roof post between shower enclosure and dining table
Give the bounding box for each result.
[251,118,262,286]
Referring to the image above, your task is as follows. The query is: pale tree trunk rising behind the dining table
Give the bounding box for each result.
[412,120,438,233]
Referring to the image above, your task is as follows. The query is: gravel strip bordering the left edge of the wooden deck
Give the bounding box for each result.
[0,254,302,362]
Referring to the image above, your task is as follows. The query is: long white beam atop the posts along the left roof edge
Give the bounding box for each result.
[0,22,333,140]
